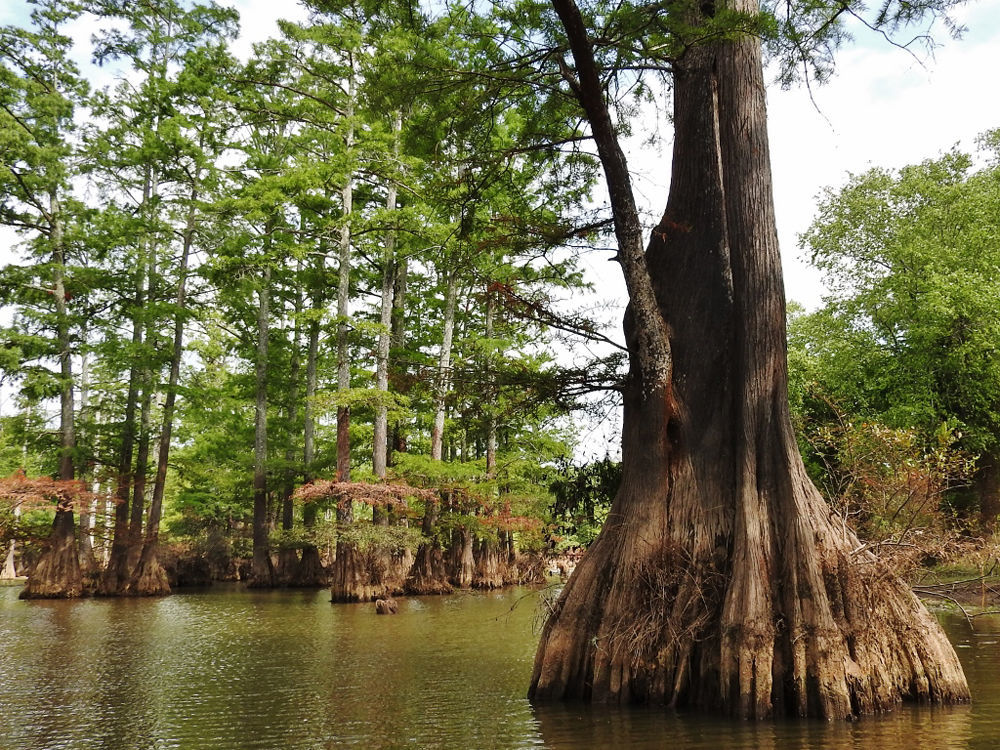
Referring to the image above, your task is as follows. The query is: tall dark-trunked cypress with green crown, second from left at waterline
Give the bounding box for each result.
[88,0,236,595]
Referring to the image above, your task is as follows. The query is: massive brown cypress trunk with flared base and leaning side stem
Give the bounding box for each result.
[530,0,968,719]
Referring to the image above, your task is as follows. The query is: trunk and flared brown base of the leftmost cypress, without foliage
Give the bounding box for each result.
[20,190,83,599]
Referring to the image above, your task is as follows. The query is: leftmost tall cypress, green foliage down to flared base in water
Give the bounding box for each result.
[0,0,88,598]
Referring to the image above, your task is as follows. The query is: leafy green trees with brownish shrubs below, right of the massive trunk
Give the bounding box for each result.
[789,140,1000,560]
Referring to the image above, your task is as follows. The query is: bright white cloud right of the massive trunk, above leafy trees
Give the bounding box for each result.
[769,2,1000,307]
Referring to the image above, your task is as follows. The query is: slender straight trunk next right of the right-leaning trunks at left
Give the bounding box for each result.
[247,266,274,588]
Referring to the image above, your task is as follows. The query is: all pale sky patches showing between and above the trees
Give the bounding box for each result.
[0,0,1000,309]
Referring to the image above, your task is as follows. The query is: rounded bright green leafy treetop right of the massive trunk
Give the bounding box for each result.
[791,139,1000,453]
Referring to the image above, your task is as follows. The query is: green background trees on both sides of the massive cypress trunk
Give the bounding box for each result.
[0,0,1000,612]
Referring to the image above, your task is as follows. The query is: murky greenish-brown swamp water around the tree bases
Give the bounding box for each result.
[0,586,1000,750]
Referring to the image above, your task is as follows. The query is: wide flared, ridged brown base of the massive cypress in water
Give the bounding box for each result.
[530,420,969,719]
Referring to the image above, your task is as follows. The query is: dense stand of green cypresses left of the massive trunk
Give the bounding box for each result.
[0,0,617,600]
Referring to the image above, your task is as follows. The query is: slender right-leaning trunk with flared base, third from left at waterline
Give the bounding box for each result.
[128,186,198,596]
